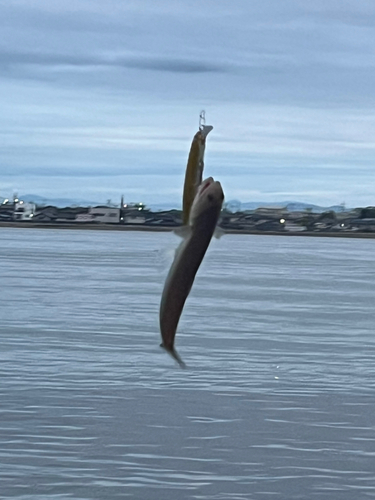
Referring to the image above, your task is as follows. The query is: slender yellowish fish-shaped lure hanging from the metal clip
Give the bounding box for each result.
[182,125,213,225]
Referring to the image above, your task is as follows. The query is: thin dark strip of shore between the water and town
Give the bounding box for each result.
[0,221,375,239]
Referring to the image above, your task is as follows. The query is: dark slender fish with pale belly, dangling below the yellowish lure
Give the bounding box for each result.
[160,177,224,367]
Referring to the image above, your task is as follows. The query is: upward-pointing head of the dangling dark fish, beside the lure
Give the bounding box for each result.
[189,177,224,226]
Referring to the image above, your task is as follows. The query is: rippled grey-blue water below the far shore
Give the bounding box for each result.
[0,228,375,500]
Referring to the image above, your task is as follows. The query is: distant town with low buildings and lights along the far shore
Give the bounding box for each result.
[0,195,375,237]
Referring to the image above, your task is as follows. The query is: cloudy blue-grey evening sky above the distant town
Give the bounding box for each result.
[0,0,375,208]
